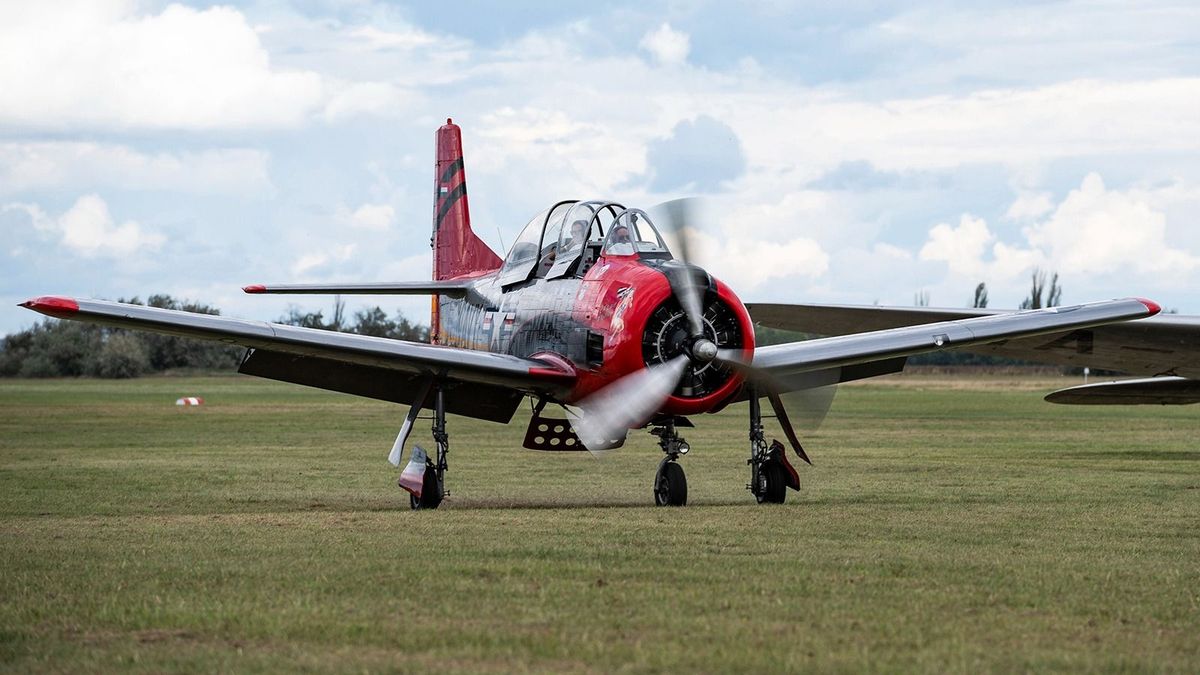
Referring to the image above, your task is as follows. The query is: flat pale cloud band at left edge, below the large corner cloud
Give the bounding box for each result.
[0,142,271,193]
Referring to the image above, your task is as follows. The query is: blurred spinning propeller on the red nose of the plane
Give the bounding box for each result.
[572,198,838,456]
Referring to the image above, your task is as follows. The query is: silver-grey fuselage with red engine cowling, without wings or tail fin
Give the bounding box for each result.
[437,233,754,414]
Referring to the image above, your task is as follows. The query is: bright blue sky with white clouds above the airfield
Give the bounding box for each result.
[0,0,1200,334]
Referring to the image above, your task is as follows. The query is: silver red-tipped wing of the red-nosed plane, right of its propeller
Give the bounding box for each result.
[754,299,1159,388]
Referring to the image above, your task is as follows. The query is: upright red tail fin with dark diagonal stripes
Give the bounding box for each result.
[432,119,503,281]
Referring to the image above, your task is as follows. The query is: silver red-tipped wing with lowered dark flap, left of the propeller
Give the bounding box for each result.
[22,297,575,422]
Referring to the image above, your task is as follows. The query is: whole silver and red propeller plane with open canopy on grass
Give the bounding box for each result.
[22,119,1159,509]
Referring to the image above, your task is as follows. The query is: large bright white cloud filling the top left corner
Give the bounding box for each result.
[0,0,322,131]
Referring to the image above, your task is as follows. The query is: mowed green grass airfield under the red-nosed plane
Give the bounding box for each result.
[0,369,1200,673]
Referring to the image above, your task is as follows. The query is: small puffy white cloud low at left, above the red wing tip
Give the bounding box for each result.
[4,195,167,258]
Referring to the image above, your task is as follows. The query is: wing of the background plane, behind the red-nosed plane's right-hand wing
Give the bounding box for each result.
[746,304,1200,378]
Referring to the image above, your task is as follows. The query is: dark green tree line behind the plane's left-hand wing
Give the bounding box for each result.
[0,294,428,378]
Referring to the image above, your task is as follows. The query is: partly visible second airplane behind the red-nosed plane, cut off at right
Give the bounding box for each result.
[746,303,1200,406]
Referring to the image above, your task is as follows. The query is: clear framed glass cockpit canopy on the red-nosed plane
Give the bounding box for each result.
[499,199,671,286]
